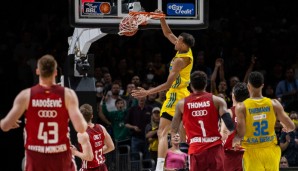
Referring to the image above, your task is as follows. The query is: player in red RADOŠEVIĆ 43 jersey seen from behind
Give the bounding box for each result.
[0,55,92,171]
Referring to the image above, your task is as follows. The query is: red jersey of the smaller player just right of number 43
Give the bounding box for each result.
[80,124,106,171]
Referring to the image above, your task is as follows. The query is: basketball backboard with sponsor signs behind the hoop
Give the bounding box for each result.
[69,0,209,30]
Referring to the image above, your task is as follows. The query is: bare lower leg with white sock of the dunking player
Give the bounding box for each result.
[156,117,171,171]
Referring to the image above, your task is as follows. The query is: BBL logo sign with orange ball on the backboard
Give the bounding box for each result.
[83,2,111,15]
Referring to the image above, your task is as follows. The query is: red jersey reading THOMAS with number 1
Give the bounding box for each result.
[182,92,222,154]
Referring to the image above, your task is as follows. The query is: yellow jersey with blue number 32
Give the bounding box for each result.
[242,97,277,148]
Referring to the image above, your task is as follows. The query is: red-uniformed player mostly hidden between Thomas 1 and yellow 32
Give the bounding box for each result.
[221,82,249,171]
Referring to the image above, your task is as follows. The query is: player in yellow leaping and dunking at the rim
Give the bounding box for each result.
[132,10,195,171]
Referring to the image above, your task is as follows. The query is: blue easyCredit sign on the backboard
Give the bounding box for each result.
[167,3,195,16]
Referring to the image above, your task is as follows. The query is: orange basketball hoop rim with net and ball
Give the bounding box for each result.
[118,11,165,36]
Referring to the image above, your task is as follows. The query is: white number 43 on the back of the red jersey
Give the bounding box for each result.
[37,122,58,144]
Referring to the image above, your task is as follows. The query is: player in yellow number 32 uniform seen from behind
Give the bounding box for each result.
[233,71,295,171]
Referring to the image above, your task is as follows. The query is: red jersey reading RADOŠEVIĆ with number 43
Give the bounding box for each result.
[24,84,70,153]
